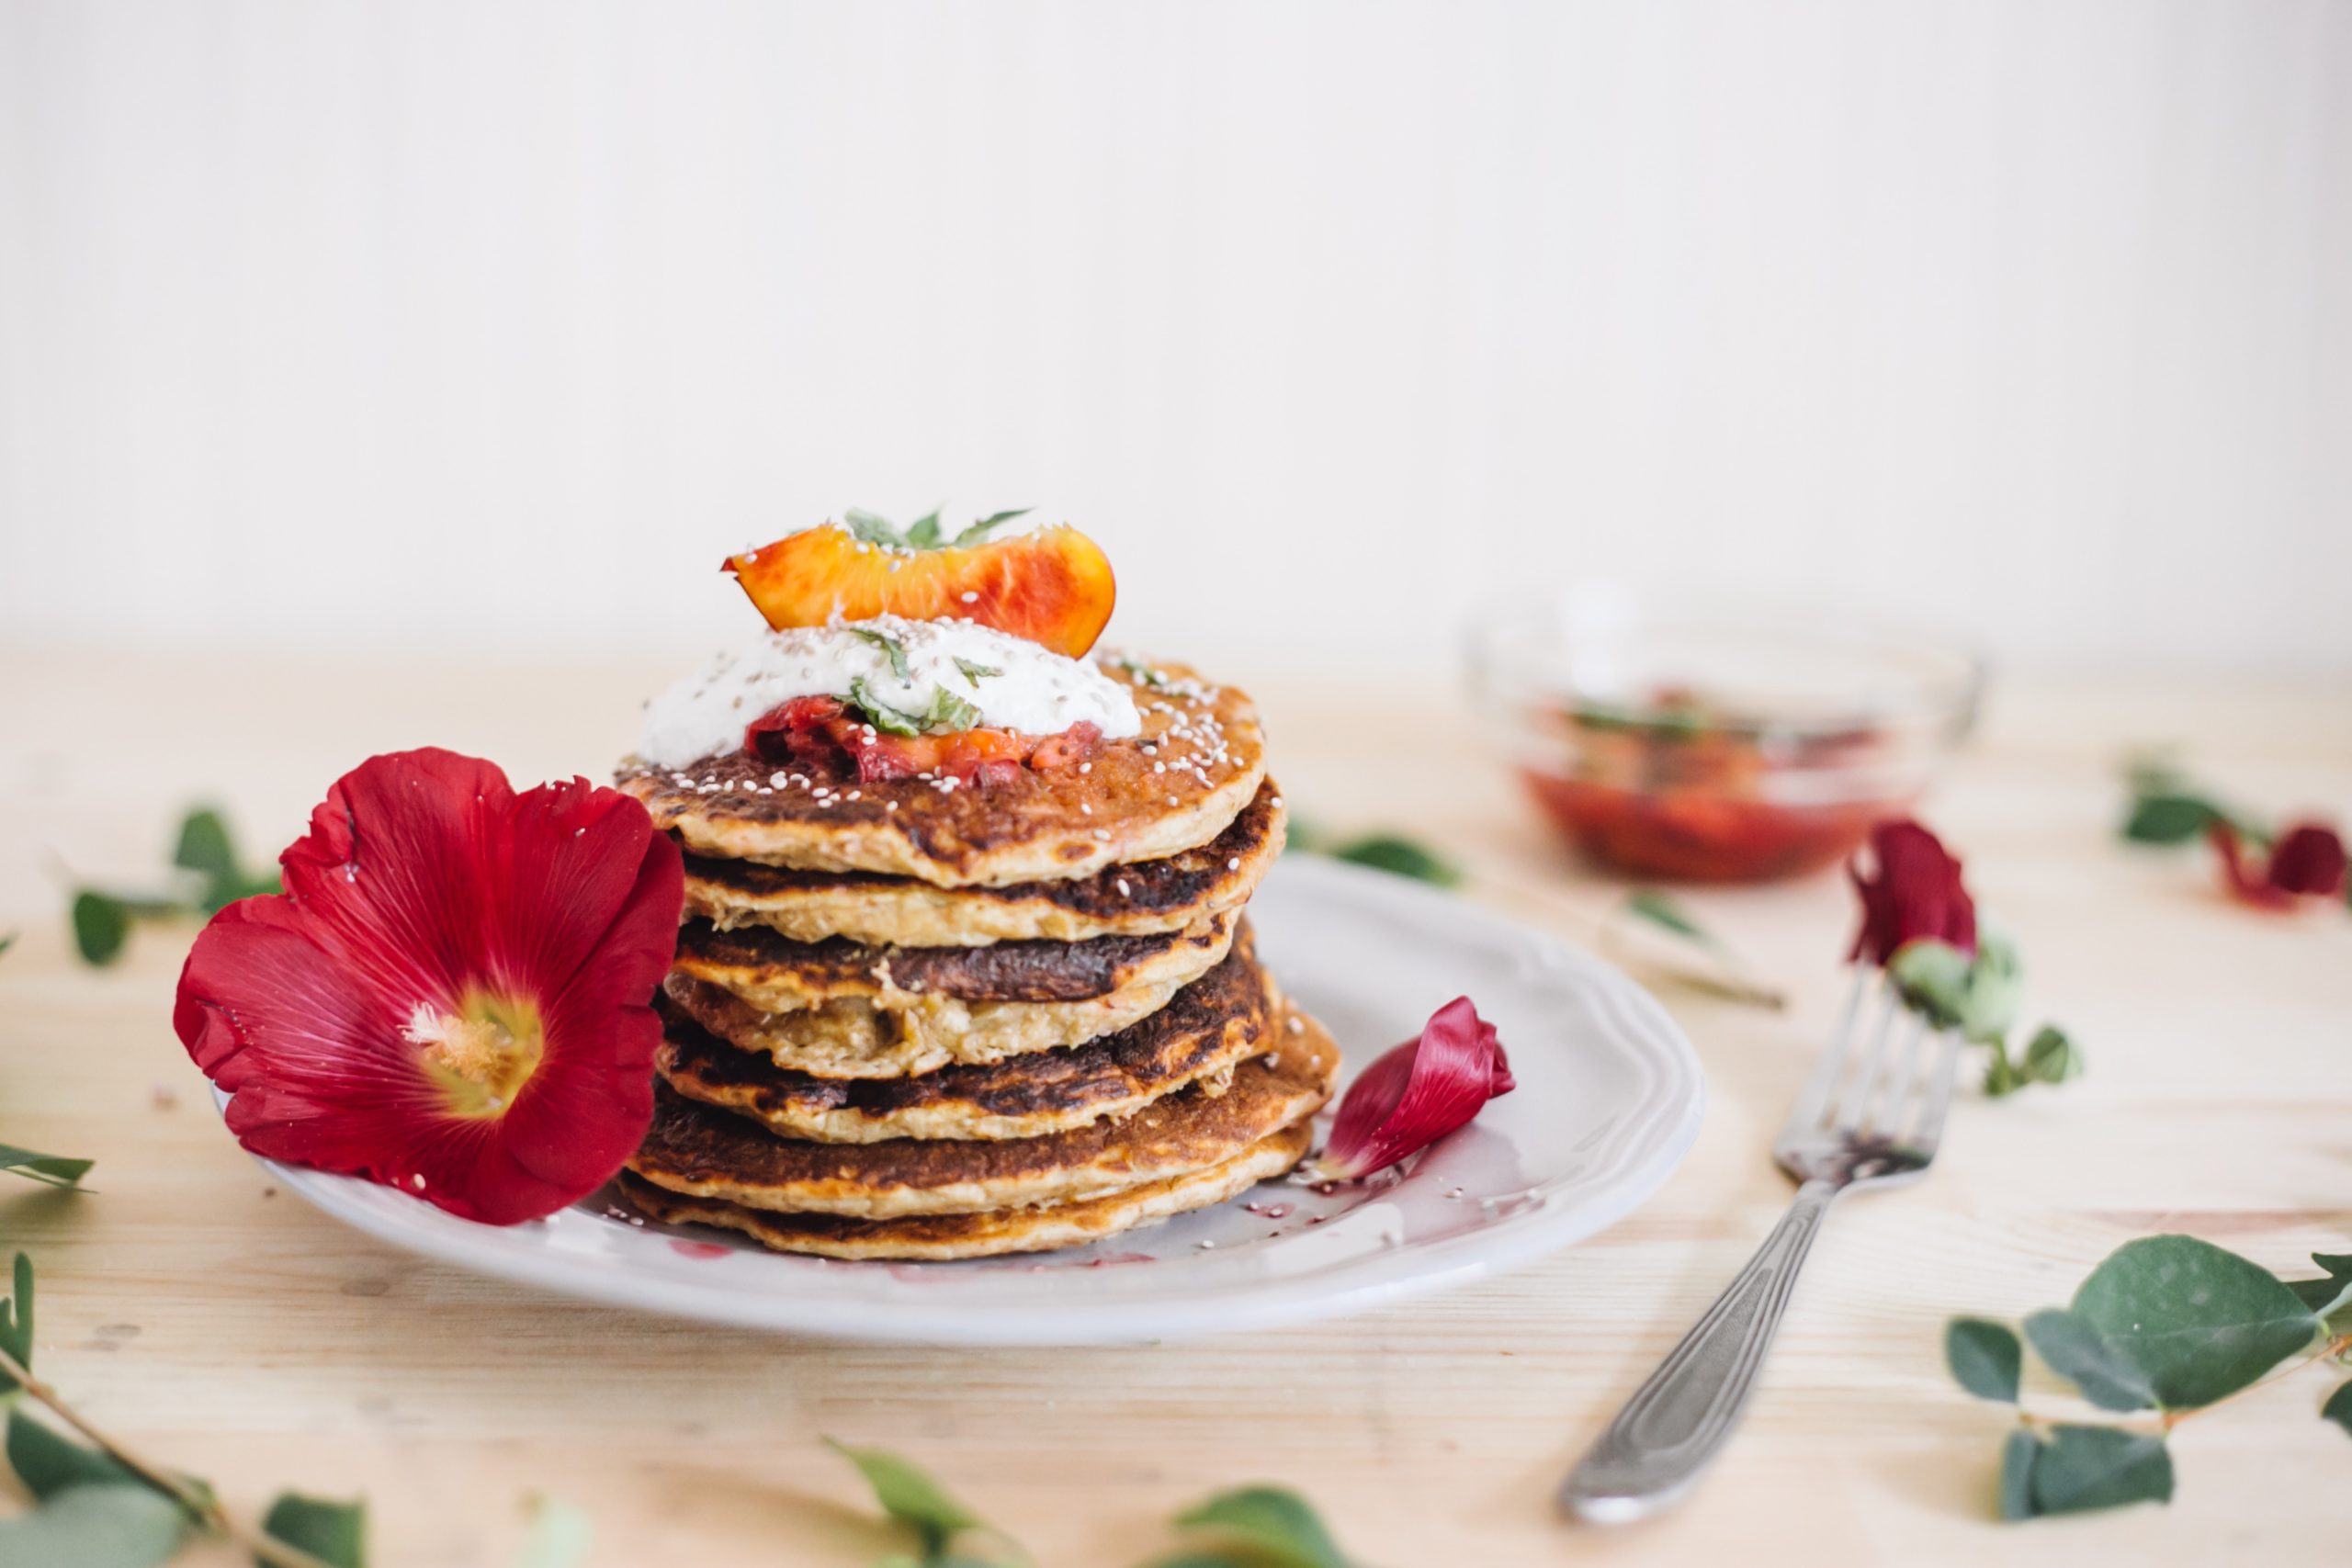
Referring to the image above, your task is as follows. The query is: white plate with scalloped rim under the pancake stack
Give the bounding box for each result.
[238,856,1705,1345]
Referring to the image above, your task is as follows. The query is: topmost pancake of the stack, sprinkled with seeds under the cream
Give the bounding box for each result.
[618,659,1265,886]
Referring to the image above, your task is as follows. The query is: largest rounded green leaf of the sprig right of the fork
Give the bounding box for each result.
[2069,1236,2319,1411]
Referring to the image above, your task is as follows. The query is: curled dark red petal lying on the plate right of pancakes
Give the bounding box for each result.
[1315,997,1515,1180]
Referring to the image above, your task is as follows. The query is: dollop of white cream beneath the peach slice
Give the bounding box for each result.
[638,616,1143,769]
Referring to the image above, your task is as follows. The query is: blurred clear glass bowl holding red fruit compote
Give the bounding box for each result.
[1473,583,1985,882]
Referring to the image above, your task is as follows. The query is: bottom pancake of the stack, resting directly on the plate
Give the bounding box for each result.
[618,1122,1315,1262]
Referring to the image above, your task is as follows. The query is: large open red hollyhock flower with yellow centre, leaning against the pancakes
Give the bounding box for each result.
[172,750,684,1224]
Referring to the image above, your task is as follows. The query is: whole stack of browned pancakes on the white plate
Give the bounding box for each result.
[621,660,1339,1258]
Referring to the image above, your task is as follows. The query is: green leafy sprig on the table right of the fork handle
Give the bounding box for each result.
[1943,1236,2352,1518]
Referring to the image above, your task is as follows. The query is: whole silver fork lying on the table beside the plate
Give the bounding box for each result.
[1559,968,1962,1523]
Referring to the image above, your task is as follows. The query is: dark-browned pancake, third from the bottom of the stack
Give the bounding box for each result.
[654,950,1270,1143]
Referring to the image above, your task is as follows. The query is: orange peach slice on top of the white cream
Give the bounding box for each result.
[724,522,1117,659]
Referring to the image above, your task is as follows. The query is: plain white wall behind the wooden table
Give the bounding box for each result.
[0,0,2352,672]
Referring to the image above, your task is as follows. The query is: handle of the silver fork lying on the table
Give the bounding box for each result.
[1559,1180,1844,1523]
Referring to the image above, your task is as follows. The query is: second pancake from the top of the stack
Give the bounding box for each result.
[687,778,1284,947]
